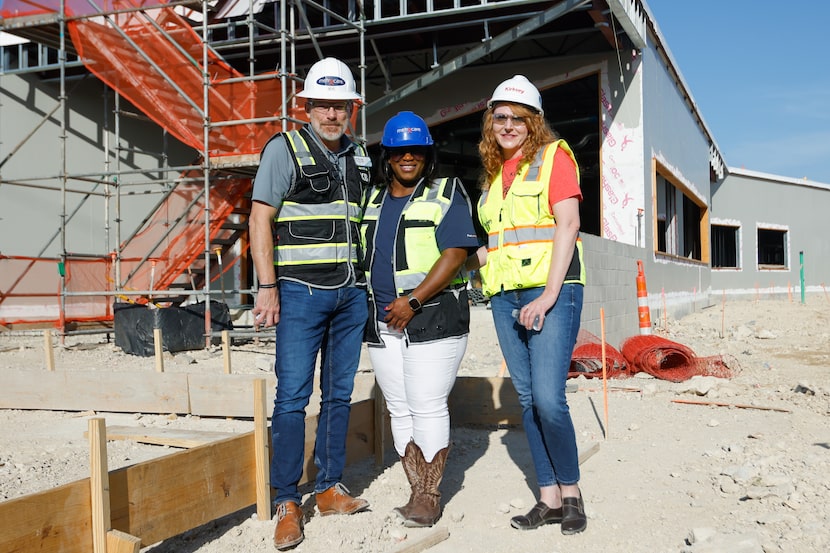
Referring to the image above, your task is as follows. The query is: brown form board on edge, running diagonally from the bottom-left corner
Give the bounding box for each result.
[0,399,374,553]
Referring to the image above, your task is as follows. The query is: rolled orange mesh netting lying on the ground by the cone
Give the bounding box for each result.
[620,335,733,382]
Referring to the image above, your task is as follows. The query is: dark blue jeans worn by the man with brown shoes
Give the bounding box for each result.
[271,281,369,504]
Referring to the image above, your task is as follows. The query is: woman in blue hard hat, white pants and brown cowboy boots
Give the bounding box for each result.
[361,111,479,527]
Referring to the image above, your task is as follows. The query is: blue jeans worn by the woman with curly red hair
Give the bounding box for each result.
[490,284,584,488]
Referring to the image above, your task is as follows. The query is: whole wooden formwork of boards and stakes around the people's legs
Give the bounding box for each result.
[0,371,521,553]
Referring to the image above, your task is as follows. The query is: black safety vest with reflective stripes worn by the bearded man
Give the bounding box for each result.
[274,127,369,288]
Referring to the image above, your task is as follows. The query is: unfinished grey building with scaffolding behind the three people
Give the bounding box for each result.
[0,0,830,342]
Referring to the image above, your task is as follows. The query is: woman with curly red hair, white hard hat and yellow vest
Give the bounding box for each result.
[468,75,588,534]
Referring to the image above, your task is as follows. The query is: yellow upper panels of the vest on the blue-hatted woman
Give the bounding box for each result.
[361,178,469,296]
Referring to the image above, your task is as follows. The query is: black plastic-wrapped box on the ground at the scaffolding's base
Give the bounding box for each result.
[113,301,233,357]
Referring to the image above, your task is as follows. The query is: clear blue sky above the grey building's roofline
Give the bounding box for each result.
[646,0,830,184]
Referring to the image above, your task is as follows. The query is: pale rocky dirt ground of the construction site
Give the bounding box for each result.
[0,296,830,553]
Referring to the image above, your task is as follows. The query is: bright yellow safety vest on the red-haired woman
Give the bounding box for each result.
[478,140,585,296]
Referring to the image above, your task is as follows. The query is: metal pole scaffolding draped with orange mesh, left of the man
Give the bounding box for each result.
[0,0,372,336]
